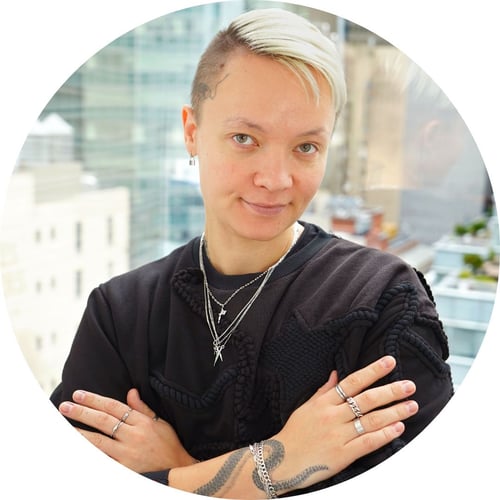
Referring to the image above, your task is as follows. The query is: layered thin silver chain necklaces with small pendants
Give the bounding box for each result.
[199,222,302,366]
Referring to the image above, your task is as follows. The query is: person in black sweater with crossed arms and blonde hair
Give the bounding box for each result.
[51,9,453,498]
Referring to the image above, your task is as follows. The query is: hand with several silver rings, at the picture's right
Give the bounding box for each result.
[269,356,418,487]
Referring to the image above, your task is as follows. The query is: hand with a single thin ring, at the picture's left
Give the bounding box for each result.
[59,389,196,472]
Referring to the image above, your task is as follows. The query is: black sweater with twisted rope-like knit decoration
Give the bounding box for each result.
[52,224,453,494]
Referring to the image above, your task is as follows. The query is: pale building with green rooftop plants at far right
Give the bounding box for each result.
[428,207,500,385]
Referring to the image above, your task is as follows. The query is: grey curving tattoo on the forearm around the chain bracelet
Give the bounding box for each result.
[194,439,328,496]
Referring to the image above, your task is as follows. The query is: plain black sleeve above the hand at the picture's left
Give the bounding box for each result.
[50,288,132,426]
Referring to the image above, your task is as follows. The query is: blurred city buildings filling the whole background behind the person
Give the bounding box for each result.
[0,1,500,393]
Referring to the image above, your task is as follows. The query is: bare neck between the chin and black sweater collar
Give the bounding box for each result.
[204,225,303,275]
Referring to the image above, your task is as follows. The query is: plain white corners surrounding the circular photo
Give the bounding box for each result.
[0,0,500,500]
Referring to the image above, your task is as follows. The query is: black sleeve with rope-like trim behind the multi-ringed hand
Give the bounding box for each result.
[334,273,454,483]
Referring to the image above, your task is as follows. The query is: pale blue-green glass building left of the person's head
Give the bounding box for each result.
[42,2,244,267]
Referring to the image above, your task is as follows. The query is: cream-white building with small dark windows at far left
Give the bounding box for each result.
[0,115,130,392]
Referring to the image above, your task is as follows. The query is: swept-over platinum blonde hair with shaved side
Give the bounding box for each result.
[191,8,346,118]
